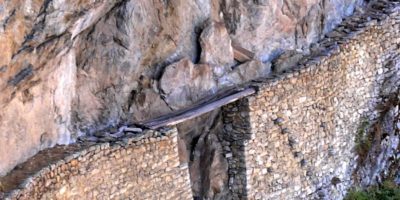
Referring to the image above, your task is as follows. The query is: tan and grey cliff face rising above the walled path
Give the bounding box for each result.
[0,0,363,178]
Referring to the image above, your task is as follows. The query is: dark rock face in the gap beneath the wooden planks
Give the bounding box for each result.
[178,110,229,199]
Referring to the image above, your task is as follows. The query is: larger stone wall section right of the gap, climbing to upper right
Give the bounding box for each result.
[224,2,400,199]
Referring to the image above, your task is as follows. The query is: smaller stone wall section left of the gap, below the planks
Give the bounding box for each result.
[1,129,192,199]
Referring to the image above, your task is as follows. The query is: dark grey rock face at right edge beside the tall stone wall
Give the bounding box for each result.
[354,57,400,187]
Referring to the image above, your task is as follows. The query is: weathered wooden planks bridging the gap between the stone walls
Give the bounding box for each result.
[141,88,256,129]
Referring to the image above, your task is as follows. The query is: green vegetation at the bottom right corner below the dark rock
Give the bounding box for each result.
[344,181,400,200]
